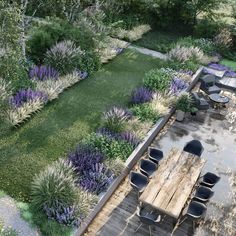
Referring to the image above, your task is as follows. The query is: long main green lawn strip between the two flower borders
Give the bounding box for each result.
[0,50,160,201]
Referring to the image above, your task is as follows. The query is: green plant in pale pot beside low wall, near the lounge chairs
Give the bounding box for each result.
[176,92,193,121]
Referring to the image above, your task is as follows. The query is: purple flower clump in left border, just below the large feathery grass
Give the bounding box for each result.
[29,66,59,81]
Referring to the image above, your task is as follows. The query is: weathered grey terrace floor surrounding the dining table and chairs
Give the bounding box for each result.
[85,93,236,236]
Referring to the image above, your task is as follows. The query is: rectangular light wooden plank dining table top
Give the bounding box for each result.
[139,148,205,219]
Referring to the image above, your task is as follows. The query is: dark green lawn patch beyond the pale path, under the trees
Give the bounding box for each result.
[134,30,186,53]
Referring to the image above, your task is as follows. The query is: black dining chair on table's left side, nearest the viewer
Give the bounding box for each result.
[129,171,148,193]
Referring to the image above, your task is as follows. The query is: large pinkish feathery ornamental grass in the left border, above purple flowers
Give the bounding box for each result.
[45,41,82,75]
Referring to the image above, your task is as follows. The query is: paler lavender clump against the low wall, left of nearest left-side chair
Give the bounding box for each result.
[79,163,114,195]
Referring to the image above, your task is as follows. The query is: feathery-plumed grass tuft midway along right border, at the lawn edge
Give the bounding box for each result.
[104,106,132,132]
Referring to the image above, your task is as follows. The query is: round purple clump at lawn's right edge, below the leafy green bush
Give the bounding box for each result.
[131,87,153,104]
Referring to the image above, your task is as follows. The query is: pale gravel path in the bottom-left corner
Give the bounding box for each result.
[0,196,40,236]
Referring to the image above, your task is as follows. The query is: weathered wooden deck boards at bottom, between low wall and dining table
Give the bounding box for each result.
[84,171,193,236]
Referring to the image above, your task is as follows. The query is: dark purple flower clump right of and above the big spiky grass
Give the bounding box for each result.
[68,144,104,175]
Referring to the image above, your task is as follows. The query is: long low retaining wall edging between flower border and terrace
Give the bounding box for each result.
[75,67,203,236]
